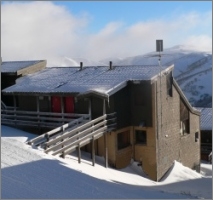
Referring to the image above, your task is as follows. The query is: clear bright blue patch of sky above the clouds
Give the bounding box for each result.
[54,1,212,31]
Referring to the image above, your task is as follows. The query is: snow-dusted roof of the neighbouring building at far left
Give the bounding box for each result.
[1,60,42,73]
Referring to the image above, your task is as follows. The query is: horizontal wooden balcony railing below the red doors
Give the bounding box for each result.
[1,107,89,128]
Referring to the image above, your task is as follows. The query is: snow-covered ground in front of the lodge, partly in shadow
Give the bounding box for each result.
[1,126,212,199]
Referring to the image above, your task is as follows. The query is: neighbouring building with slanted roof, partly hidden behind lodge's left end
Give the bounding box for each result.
[1,60,46,106]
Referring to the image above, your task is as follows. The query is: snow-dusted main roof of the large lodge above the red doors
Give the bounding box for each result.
[3,65,173,96]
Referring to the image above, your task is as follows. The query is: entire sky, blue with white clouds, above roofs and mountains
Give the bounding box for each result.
[1,1,212,64]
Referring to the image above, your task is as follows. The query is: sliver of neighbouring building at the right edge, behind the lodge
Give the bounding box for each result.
[196,107,212,160]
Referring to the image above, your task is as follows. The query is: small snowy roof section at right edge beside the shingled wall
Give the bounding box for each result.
[196,107,212,130]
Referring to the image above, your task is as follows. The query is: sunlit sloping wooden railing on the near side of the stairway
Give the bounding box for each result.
[39,113,116,157]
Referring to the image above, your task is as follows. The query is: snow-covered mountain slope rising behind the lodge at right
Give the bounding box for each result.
[102,46,212,107]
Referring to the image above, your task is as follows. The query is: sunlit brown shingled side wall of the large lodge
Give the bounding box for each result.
[155,75,200,181]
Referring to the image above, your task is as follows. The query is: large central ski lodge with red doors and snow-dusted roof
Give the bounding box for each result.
[3,63,200,181]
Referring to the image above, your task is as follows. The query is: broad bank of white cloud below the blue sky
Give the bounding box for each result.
[1,1,212,66]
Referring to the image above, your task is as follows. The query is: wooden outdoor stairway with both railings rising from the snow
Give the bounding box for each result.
[27,113,116,158]
